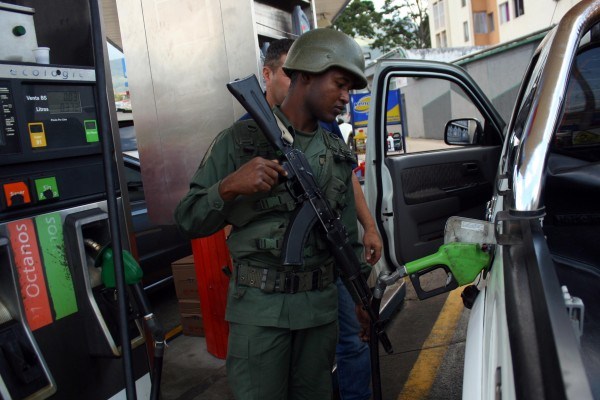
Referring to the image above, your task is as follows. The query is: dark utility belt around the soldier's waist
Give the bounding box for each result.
[236,262,335,294]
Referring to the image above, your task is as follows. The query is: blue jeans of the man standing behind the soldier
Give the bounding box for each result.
[335,278,371,400]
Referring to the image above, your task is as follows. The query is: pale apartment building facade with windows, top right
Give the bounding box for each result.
[429,0,579,48]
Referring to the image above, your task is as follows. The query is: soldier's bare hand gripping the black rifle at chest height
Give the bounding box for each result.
[219,157,287,201]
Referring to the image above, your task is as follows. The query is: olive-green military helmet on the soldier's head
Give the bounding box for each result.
[283,28,367,89]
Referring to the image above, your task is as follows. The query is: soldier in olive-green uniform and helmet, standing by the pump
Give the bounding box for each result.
[175,29,370,400]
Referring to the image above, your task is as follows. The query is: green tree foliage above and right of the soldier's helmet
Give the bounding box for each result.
[332,0,431,52]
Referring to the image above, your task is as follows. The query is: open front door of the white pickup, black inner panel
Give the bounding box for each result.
[365,60,505,298]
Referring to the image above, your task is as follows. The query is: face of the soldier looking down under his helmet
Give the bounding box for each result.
[307,68,354,122]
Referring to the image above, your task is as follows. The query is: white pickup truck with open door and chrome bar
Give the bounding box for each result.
[364,0,600,400]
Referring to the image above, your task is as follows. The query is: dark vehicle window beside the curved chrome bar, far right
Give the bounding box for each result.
[544,27,600,265]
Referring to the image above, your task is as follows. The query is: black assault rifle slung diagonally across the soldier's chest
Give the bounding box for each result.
[227,75,393,354]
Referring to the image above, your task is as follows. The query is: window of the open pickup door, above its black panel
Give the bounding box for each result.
[385,76,485,156]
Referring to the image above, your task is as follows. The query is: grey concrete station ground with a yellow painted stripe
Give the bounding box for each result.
[152,276,468,400]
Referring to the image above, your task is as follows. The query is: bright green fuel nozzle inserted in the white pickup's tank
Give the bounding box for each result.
[373,242,491,300]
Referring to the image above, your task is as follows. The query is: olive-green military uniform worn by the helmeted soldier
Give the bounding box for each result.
[175,108,370,400]
